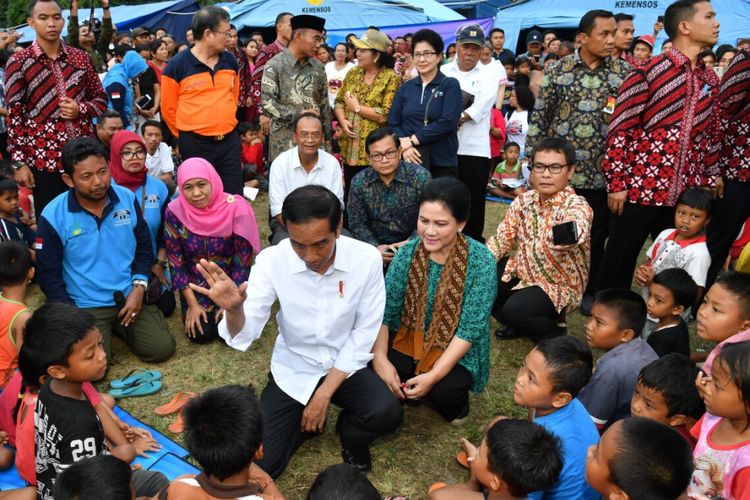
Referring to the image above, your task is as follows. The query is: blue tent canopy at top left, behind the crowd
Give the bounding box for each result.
[18,0,200,42]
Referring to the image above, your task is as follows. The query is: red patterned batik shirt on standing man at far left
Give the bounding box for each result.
[5,41,107,172]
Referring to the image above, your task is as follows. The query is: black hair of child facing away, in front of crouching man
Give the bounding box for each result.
[182,385,263,481]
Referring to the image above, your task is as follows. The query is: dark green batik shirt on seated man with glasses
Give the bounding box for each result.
[346,161,431,246]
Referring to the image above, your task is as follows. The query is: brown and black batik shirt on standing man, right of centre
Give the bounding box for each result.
[526,52,630,190]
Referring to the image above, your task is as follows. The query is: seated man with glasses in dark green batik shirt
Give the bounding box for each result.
[346,127,432,264]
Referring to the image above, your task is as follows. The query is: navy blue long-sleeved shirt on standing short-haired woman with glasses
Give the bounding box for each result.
[388,71,463,168]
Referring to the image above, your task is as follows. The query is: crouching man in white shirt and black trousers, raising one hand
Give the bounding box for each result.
[190,184,403,478]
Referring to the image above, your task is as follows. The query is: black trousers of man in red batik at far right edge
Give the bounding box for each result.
[706,181,750,290]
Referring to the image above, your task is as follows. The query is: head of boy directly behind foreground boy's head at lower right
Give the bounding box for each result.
[630,353,706,447]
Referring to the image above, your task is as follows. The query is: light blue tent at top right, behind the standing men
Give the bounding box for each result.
[495,0,750,53]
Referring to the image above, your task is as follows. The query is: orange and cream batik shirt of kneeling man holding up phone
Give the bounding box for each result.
[487,187,593,312]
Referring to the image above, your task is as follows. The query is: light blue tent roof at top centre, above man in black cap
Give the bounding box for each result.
[228,0,463,30]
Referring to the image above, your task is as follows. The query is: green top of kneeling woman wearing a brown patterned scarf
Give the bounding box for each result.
[383,238,497,392]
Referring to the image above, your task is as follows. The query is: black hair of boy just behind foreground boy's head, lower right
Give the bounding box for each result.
[638,352,706,420]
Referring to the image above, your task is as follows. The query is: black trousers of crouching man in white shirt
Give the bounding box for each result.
[258,367,404,478]
